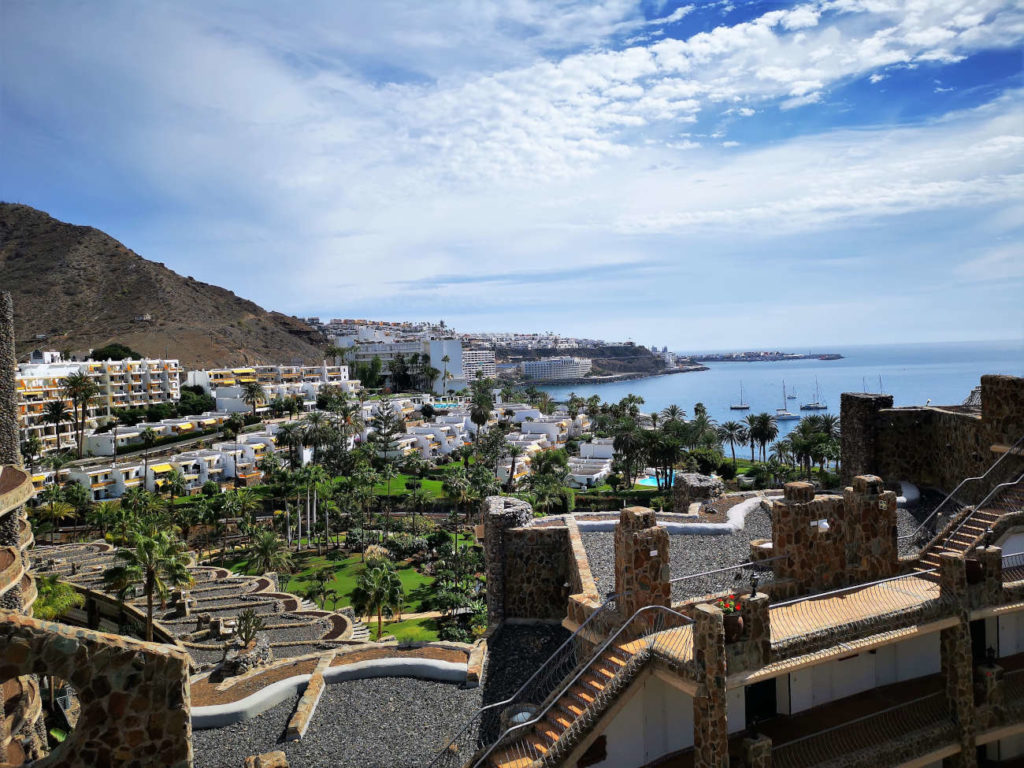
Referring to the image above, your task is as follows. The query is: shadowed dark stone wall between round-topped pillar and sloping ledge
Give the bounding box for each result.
[505,527,571,621]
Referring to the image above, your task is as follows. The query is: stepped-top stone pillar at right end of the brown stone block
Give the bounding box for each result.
[843,475,899,582]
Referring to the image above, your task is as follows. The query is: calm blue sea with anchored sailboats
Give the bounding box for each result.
[544,339,1024,436]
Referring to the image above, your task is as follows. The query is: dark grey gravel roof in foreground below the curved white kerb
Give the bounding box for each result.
[194,678,481,768]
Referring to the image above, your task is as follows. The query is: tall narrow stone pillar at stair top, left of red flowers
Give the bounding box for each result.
[693,604,729,768]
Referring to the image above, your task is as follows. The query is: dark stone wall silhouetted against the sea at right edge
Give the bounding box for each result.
[842,376,1024,495]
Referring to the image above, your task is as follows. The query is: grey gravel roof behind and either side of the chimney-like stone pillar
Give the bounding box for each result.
[582,510,771,600]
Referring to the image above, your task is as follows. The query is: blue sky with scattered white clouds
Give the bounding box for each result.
[0,0,1024,349]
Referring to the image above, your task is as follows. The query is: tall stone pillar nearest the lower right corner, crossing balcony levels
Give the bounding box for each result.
[939,552,978,768]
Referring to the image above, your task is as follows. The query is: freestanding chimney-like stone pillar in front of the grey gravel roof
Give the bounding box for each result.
[614,507,672,616]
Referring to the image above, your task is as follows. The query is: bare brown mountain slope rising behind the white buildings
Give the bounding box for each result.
[0,203,326,368]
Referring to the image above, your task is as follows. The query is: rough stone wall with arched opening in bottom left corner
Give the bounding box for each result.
[0,613,193,768]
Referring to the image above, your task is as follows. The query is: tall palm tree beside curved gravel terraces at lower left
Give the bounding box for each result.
[103,530,193,643]
